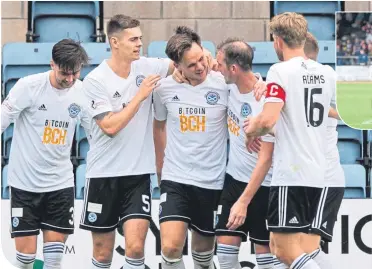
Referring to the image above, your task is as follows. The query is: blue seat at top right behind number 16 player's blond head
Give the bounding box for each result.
[273,1,341,40]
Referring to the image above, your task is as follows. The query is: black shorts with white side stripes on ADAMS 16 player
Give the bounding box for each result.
[267,186,323,233]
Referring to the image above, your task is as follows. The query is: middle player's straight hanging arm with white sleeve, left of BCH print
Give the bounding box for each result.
[153,92,167,186]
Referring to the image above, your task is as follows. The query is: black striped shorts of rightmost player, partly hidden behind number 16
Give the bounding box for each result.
[310,187,345,242]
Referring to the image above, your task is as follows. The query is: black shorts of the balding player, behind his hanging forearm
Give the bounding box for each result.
[216,174,270,245]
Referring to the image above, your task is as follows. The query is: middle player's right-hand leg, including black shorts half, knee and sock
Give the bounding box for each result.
[190,186,222,269]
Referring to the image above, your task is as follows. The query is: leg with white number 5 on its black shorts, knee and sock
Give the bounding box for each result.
[119,174,151,269]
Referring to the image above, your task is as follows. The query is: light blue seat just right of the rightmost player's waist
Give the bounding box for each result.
[342,164,366,198]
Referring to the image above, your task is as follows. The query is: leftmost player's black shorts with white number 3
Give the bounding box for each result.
[10,187,75,238]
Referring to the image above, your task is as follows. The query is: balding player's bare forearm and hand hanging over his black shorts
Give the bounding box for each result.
[227,139,274,230]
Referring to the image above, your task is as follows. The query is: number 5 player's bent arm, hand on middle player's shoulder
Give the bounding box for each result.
[83,75,160,137]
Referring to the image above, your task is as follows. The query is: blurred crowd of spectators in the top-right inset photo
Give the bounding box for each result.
[336,13,372,65]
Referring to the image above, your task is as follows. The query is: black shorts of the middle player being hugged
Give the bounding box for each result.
[159,180,221,236]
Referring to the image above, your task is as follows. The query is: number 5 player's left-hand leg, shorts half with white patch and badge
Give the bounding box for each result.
[80,178,120,269]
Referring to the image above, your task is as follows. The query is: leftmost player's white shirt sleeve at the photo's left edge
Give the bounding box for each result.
[1,79,32,133]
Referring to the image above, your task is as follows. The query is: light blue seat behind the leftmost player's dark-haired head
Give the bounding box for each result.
[2,43,111,94]
